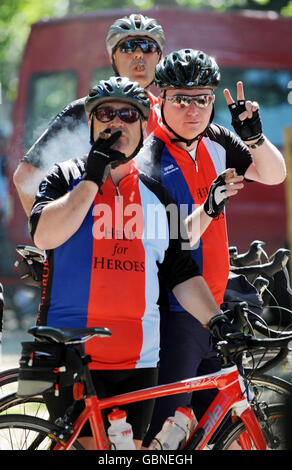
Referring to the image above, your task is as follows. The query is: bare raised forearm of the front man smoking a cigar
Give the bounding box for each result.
[34,181,98,250]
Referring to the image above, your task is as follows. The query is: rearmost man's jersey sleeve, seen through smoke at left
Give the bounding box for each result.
[21,99,89,171]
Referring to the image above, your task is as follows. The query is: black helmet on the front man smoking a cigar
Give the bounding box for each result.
[85,77,151,120]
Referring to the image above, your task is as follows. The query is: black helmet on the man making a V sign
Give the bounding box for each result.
[154,49,220,89]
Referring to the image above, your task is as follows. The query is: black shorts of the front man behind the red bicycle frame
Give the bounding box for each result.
[44,368,158,440]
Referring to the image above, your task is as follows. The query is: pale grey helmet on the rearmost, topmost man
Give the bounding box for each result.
[106,13,165,54]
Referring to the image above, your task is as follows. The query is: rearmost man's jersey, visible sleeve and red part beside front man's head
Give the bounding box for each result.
[21,92,160,172]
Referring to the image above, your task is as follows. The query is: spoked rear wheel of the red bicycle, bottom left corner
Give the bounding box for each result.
[0,415,84,451]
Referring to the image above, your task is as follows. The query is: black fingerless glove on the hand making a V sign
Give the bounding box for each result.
[228,100,263,141]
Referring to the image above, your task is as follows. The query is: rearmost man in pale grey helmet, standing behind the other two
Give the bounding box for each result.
[14,13,165,215]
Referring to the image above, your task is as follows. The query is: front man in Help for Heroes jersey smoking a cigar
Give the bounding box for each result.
[30,77,237,448]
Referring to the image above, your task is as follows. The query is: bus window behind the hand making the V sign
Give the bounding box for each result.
[215,67,292,147]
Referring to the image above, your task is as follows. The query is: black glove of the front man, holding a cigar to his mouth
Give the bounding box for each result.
[82,129,125,192]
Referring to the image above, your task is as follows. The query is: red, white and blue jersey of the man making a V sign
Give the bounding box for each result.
[136,124,252,311]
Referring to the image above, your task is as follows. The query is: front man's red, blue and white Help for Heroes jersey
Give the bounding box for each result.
[30,157,199,369]
